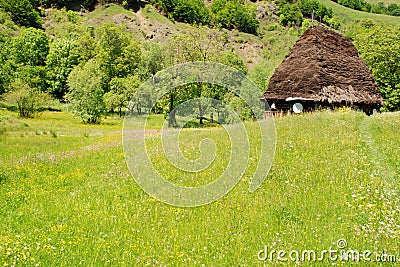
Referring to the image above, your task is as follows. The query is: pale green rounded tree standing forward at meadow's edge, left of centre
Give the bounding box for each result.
[66,60,106,123]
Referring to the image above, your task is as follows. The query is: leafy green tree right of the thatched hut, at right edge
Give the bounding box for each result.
[354,23,400,111]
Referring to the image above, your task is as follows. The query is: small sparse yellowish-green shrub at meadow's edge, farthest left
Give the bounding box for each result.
[2,79,51,118]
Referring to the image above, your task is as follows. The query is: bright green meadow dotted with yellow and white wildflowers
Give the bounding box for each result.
[0,111,400,266]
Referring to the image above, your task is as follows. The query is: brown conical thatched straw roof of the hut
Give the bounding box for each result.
[263,26,383,108]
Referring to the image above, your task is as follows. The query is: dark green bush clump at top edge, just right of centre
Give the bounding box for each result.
[211,0,259,34]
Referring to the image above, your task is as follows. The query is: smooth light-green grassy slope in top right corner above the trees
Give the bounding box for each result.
[319,0,400,24]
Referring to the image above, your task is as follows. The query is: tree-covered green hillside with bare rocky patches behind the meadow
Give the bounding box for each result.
[0,0,400,118]
